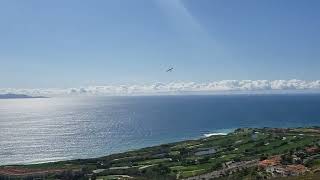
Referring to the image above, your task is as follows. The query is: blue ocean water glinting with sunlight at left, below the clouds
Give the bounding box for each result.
[0,94,320,165]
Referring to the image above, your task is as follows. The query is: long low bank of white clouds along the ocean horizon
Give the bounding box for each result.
[0,79,320,96]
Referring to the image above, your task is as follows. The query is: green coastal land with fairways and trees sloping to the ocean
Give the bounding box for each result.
[0,127,320,179]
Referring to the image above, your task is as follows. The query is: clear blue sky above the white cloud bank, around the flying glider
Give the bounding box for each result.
[0,0,320,88]
